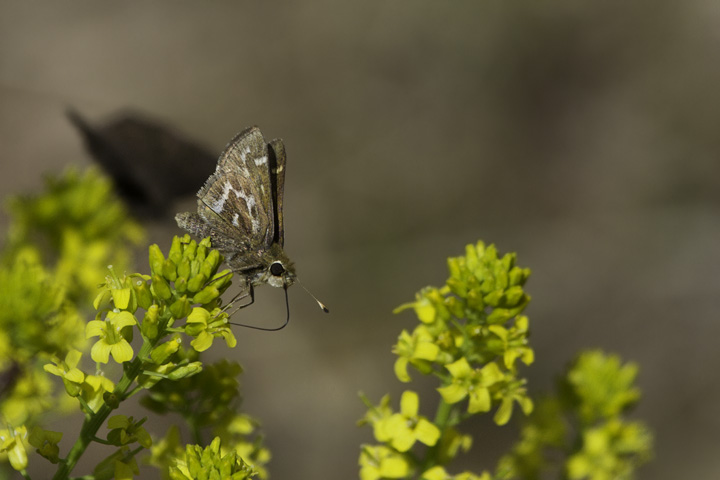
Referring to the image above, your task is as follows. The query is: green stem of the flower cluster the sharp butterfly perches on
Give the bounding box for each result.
[53,342,153,480]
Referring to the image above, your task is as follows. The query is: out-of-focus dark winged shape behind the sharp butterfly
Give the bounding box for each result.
[66,109,217,218]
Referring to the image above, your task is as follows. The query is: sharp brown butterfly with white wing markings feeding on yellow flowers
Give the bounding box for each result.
[175,127,327,328]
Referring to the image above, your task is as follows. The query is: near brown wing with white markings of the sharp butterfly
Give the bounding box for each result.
[198,127,276,251]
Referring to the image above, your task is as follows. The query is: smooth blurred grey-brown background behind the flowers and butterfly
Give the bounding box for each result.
[0,0,720,479]
